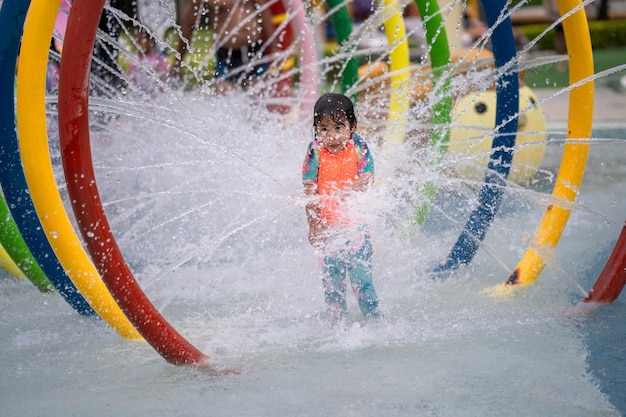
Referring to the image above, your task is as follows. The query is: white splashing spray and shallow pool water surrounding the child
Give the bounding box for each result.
[0,0,626,416]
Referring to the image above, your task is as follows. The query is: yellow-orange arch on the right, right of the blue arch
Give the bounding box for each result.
[493,0,594,292]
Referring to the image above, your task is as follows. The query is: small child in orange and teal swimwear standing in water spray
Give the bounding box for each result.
[302,93,380,319]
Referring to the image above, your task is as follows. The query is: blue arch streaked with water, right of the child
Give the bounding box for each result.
[435,0,519,272]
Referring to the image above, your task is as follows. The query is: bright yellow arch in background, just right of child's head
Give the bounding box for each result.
[383,0,411,143]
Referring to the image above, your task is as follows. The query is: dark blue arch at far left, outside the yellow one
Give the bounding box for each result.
[0,0,95,308]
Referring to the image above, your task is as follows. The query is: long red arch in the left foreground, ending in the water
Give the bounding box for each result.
[59,0,221,371]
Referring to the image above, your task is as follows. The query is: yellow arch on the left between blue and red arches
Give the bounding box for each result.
[17,0,141,339]
